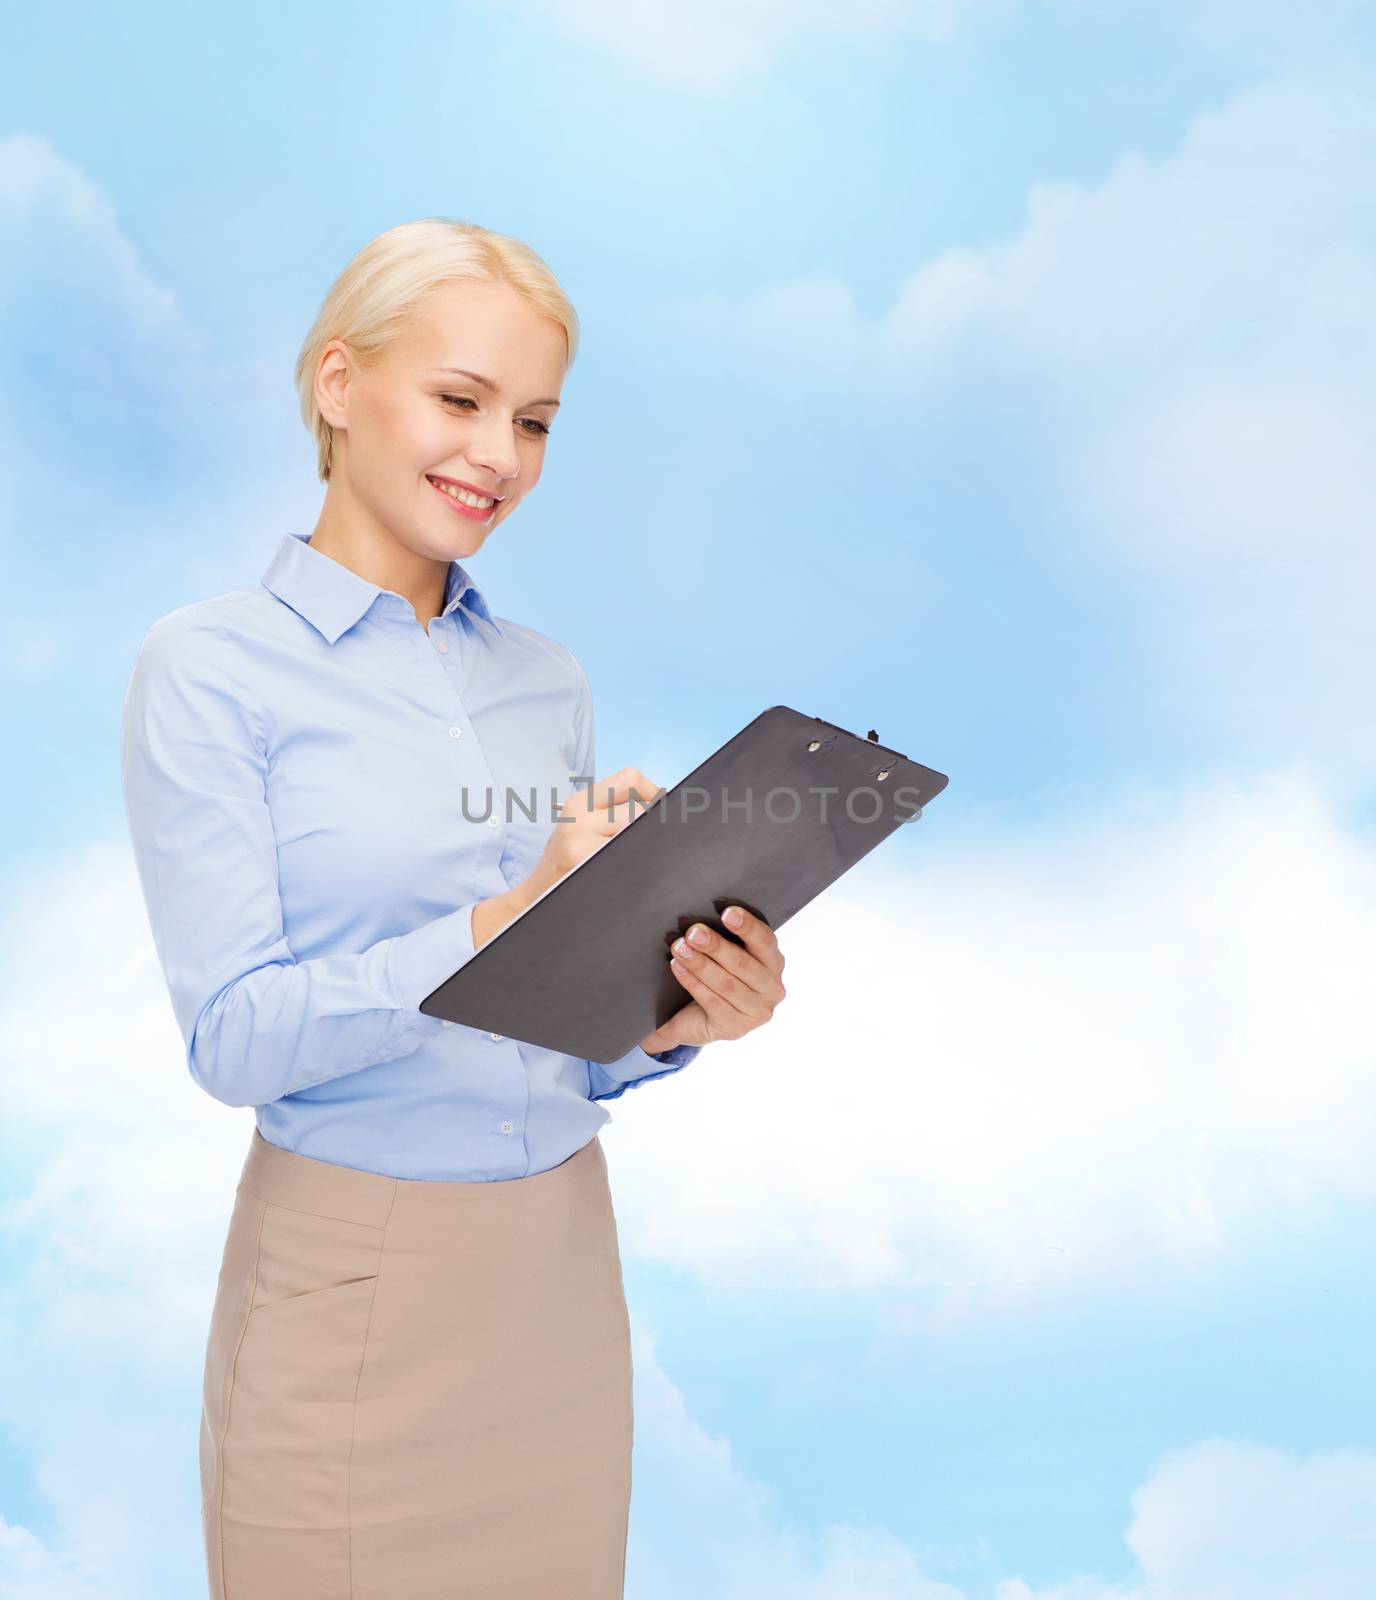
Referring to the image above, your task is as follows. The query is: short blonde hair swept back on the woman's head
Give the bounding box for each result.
[296,216,578,482]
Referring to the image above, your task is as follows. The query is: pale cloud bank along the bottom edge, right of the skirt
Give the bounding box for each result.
[627,1333,1376,1600]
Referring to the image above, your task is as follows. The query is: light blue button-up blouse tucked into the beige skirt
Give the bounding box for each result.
[122,533,701,1181]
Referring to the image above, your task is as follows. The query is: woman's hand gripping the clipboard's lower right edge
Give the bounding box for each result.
[640,906,786,1056]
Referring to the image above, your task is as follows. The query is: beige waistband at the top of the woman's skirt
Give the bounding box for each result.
[240,1128,606,1227]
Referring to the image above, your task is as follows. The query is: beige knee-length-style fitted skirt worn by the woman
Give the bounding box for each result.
[200,1128,632,1600]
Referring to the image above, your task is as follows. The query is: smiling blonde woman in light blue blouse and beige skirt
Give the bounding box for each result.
[123,219,784,1600]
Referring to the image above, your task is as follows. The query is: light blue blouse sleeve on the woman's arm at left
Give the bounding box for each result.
[122,613,478,1106]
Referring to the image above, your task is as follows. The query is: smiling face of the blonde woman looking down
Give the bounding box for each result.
[317,283,566,562]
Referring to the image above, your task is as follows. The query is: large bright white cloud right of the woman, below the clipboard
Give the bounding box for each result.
[603,773,1376,1318]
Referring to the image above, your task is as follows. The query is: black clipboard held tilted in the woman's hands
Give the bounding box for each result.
[421,706,949,1064]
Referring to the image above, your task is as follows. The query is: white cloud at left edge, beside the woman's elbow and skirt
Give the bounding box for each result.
[0,846,251,1600]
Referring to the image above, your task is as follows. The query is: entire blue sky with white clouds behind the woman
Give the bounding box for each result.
[0,0,1376,1600]
